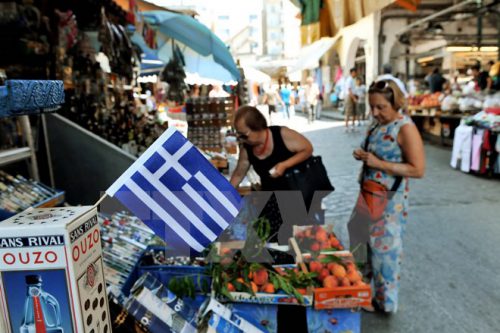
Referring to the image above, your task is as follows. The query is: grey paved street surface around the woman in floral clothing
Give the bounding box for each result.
[276,112,500,333]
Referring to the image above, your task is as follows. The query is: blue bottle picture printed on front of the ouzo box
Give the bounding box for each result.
[19,275,64,333]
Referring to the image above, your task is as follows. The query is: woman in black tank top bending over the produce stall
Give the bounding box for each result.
[230,106,313,241]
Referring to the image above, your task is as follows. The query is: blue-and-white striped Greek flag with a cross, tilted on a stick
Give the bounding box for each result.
[106,128,241,252]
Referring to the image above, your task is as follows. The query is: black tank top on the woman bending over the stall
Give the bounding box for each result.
[244,126,295,191]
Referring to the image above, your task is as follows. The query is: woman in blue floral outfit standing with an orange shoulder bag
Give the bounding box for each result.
[349,80,425,313]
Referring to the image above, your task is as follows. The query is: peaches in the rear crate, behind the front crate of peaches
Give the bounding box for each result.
[294,225,344,252]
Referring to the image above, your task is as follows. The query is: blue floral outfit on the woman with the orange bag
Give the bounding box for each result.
[363,115,412,312]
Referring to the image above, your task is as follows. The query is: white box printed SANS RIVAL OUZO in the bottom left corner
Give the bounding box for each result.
[0,206,111,333]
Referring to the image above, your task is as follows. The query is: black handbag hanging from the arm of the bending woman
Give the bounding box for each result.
[284,156,335,209]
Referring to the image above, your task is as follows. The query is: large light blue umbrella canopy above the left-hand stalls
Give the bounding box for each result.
[143,10,240,80]
